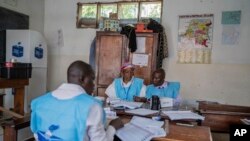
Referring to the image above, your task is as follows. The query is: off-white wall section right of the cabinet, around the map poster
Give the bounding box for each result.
[163,0,250,106]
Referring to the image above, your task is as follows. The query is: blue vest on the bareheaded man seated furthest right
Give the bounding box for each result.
[146,82,180,99]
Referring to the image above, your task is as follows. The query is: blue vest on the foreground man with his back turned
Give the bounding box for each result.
[30,93,97,141]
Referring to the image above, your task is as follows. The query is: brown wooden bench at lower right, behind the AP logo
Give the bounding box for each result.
[198,101,250,133]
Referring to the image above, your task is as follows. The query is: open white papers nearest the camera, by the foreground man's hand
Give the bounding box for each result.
[116,116,166,141]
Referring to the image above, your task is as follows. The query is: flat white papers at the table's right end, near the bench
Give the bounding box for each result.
[162,111,205,120]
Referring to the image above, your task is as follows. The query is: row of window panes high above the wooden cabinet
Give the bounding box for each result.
[76,0,162,28]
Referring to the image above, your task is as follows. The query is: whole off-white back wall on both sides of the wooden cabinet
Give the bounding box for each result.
[44,0,250,106]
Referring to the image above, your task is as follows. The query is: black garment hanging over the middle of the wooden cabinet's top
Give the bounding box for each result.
[120,25,137,52]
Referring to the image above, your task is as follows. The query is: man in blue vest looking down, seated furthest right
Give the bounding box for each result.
[146,68,180,103]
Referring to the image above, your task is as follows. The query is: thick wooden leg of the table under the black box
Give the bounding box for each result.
[14,87,25,115]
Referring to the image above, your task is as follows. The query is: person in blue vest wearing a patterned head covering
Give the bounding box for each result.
[105,63,146,102]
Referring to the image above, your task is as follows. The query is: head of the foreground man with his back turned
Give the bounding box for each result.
[67,60,94,84]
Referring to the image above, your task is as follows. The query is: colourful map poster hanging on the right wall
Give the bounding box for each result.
[177,14,214,64]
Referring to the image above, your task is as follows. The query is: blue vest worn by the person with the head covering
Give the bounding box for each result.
[114,77,143,101]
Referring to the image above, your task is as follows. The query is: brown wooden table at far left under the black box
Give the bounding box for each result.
[0,78,29,115]
